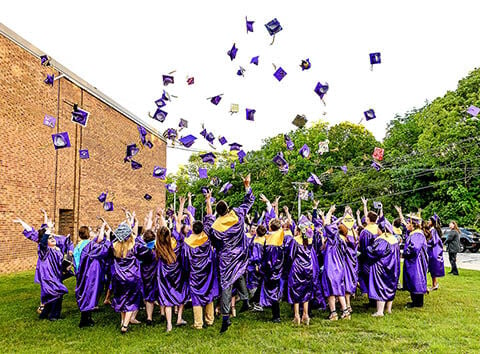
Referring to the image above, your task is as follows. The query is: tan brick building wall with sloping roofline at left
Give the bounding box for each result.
[0,24,166,273]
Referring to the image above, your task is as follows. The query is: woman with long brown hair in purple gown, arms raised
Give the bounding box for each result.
[155,197,188,332]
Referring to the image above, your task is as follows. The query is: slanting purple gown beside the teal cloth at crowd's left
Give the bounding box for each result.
[75,238,110,312]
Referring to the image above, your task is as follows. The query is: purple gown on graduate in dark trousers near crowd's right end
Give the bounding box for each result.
[403,230,428,294]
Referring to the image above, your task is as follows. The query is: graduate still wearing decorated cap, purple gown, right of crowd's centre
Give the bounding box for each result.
[288,218,320,326]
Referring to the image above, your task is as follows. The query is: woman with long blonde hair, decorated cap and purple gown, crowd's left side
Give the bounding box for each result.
[111,219,151,334]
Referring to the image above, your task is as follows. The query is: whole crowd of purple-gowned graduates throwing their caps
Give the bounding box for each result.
[14,176,450,333]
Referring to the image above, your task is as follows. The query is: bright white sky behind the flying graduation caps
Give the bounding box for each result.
[0,0,480,173]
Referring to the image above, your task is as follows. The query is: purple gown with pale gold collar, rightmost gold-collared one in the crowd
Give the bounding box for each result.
[367,234,400,301]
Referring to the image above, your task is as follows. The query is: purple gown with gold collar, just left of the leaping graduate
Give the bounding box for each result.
[183,232,219,306]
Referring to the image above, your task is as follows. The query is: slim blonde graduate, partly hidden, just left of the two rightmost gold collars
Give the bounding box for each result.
[340,206,358,313]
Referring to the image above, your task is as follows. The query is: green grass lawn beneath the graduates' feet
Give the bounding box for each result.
[0,270,480,353]
